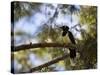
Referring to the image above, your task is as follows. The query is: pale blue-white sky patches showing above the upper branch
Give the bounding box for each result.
[14,4,81,45]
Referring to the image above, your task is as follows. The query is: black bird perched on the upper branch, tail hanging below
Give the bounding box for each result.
[60,26,76,59]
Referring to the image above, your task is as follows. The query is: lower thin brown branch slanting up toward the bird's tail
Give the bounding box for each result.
[21,54,69,73]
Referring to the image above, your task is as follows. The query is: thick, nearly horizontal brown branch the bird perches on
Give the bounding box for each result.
[11,43,75,52]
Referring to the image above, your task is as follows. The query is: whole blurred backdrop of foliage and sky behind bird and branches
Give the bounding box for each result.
[11,2,97,73]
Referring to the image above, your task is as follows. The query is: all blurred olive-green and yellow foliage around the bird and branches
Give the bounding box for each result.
[12,2,97,72]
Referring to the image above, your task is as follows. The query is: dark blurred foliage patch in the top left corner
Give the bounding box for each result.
[12,1,41,21]
